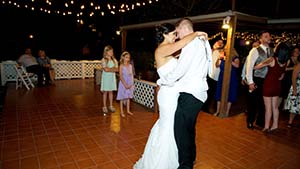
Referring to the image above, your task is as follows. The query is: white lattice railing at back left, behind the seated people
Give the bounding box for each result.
[1,60,101,85]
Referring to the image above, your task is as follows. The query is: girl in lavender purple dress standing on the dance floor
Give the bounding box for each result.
[117,51,134,117]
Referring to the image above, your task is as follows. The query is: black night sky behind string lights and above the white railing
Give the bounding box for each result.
[0,0,300,61]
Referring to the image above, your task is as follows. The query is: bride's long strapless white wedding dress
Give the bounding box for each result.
[133,58,179,169]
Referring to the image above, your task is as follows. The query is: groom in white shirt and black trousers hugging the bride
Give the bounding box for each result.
[157,18,212,169]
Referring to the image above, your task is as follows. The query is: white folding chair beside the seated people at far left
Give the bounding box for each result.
[15,64,34,90]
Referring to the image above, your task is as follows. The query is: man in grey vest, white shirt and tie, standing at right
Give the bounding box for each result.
[245,31,273,129]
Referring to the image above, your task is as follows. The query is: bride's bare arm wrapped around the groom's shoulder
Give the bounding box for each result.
[155,31,207,57]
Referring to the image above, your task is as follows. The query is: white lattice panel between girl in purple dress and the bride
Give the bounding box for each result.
[133,80,156,109]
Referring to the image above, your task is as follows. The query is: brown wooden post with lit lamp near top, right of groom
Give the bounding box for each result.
[220,15,237,118]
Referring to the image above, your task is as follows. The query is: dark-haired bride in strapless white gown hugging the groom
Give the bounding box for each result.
[133,23,203,169]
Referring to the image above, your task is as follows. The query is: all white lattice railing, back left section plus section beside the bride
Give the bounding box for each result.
[0,60,157,111]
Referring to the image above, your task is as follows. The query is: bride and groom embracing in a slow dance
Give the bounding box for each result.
[133,18,212,169]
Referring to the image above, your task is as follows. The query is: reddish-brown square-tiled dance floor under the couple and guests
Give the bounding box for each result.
[0,79,300,169]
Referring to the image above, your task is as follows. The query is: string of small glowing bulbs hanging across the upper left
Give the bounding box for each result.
[1,0,159,22]
